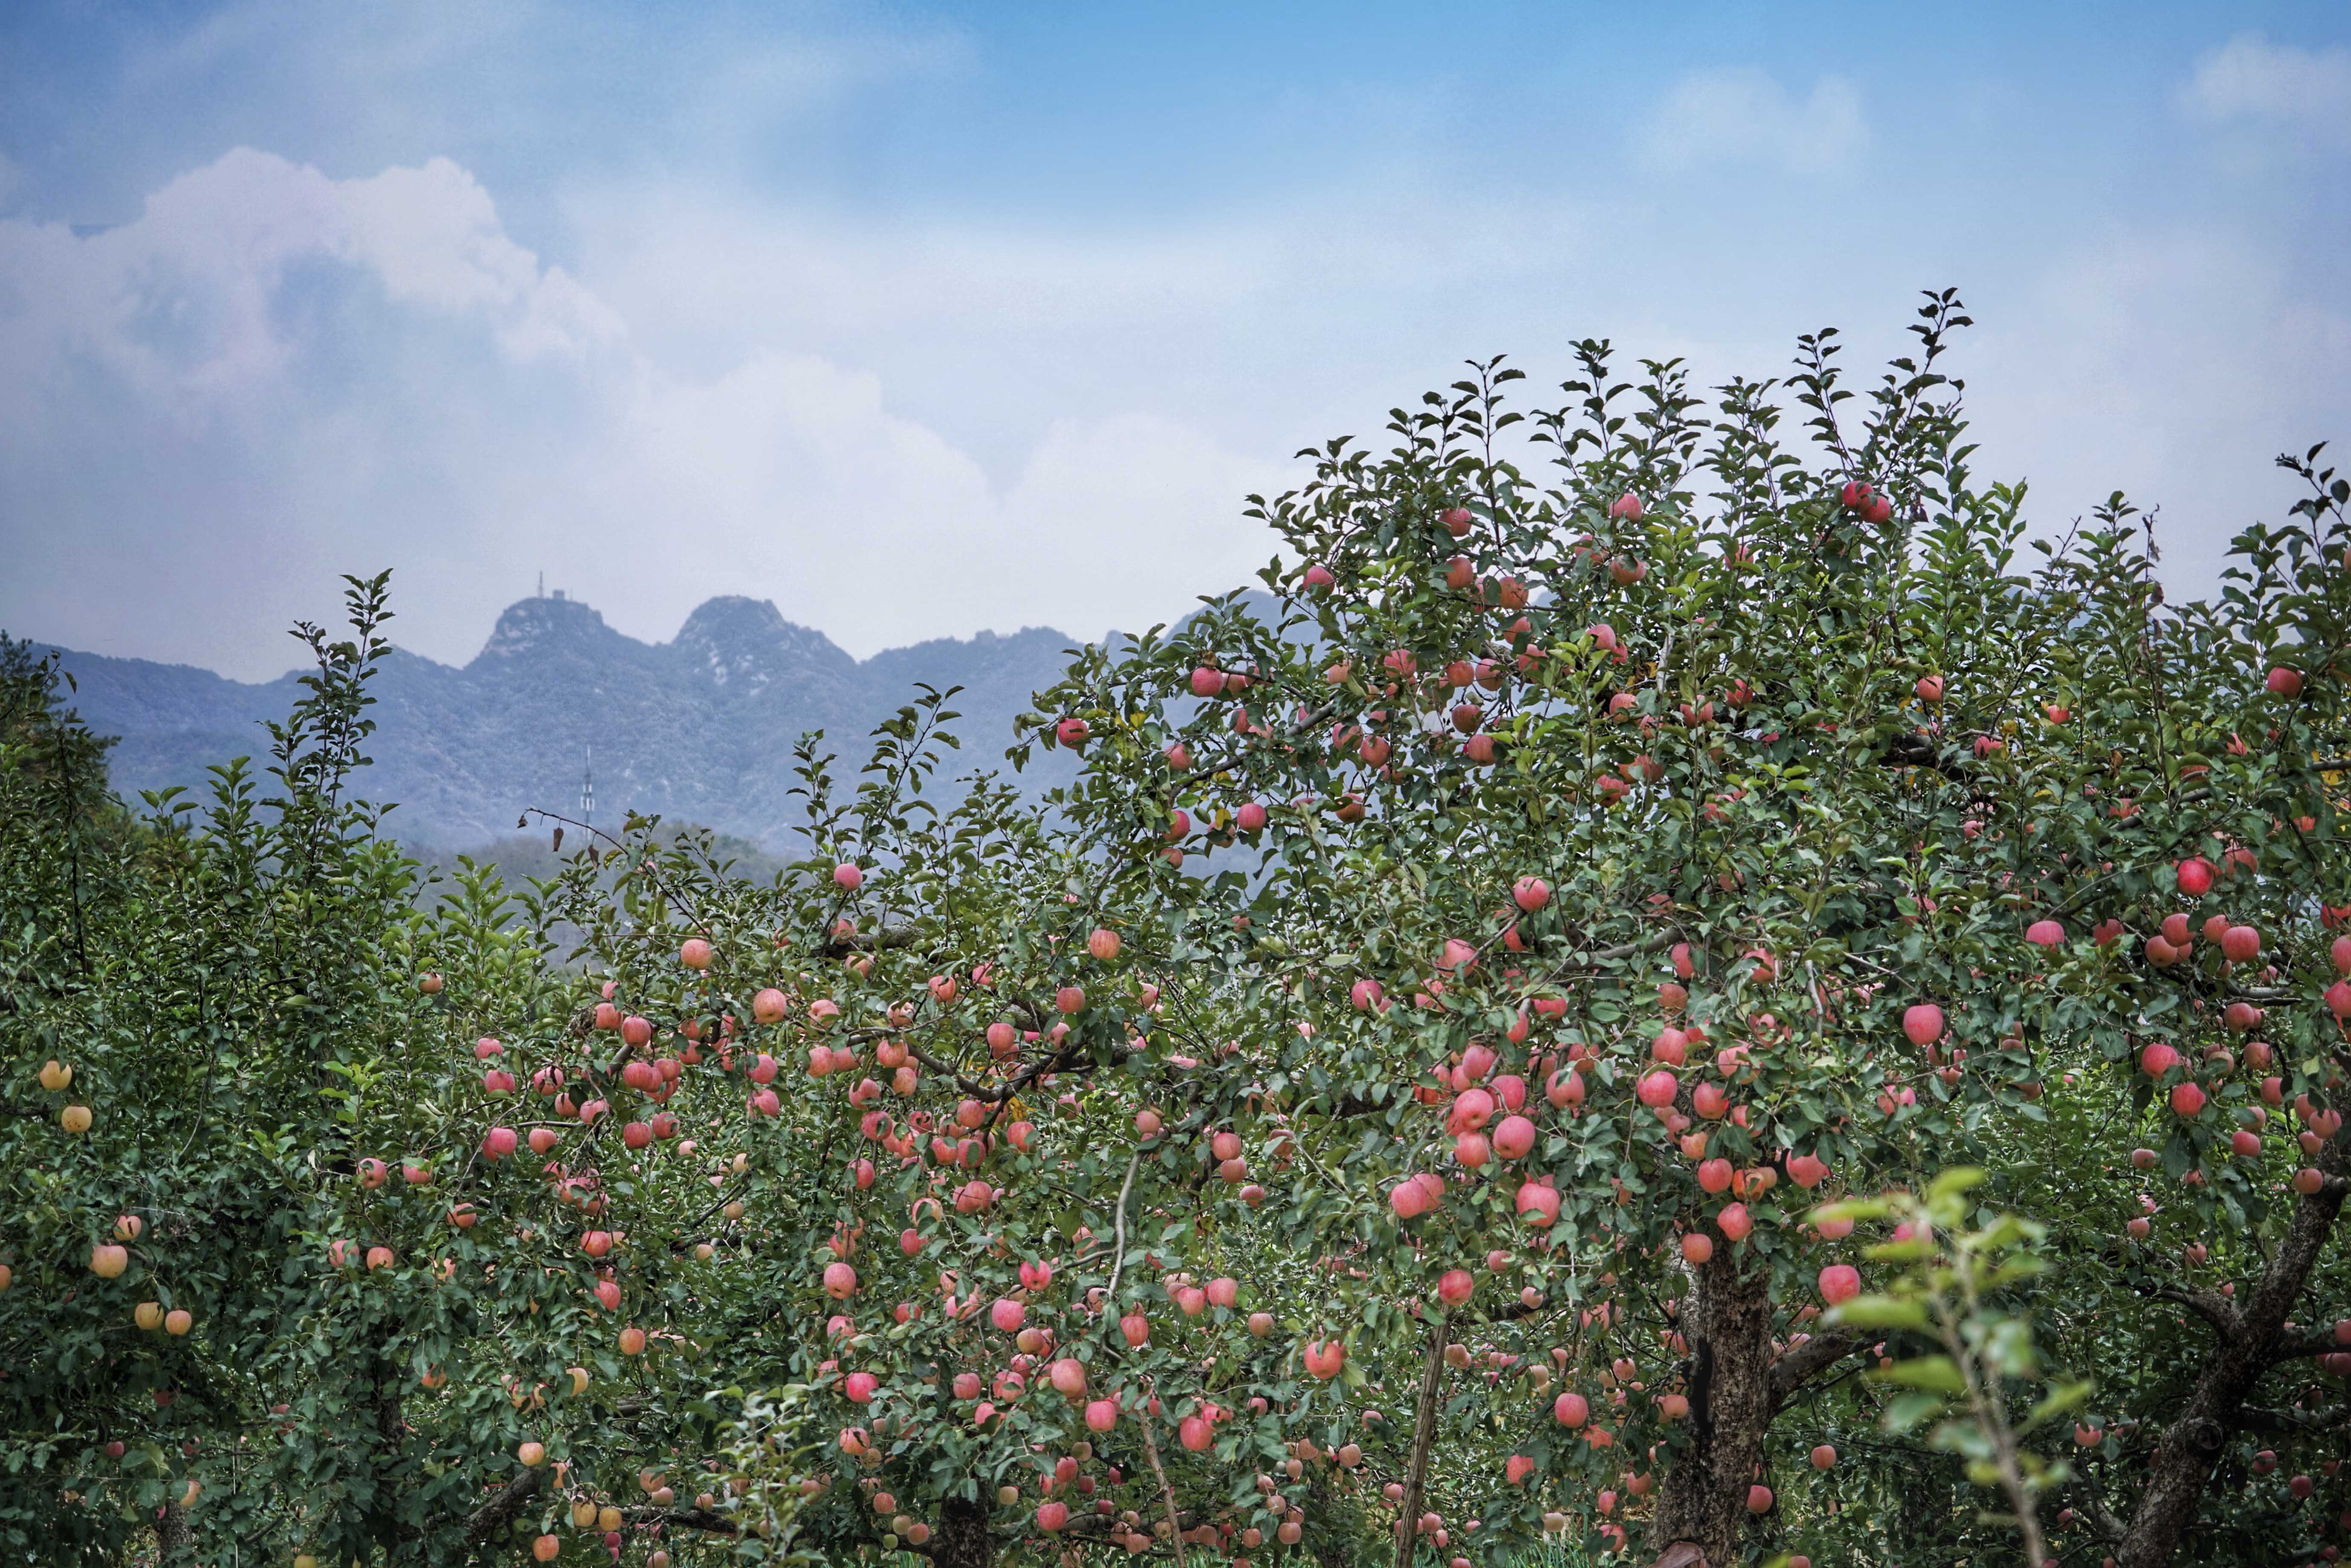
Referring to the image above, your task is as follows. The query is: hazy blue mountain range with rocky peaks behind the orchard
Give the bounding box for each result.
[40,595,1074,851]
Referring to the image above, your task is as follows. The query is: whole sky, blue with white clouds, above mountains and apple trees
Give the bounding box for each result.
[0,0,2351,677]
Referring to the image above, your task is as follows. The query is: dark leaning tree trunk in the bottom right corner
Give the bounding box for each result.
[2113,1135,2351,1568]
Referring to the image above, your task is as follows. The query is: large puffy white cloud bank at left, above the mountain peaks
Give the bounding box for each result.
[0,151,1277,675]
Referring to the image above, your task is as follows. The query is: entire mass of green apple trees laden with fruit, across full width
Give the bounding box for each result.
[0,294,2351,1568]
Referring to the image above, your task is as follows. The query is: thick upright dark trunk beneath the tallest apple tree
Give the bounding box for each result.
[1650,1246,1778,1568]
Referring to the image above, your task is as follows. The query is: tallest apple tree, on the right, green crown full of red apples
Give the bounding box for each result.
[1020,296,2351,1561]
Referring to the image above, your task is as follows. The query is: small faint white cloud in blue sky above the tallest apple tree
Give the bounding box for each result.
[1634,66,1869,176]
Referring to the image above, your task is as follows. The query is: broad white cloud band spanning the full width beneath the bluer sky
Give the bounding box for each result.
[0,141,2351,700]
